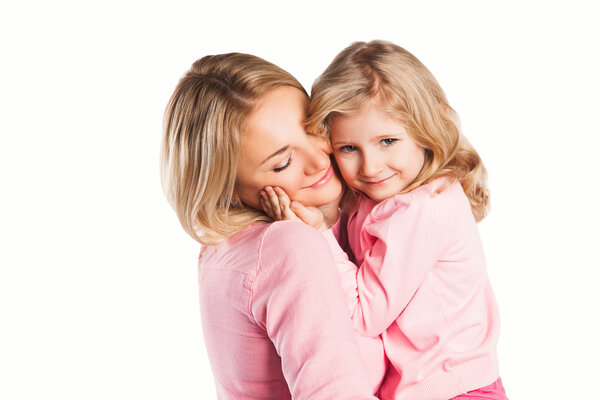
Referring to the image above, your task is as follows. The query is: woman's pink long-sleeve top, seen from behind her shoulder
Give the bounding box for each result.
[198,221,383,400]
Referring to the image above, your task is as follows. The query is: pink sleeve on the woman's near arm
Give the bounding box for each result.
[250,221,376,400]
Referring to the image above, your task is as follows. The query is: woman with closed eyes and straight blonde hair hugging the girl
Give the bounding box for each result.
[161,53,384,399]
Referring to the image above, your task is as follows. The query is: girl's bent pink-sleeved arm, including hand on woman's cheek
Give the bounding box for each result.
[262,188,442,337]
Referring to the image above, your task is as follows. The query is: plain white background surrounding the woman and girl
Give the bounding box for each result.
[0,1,600,400]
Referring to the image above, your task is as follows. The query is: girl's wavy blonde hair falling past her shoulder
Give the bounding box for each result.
[306,40,489,221]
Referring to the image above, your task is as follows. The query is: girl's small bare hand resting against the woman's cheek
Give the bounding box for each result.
[260,186,328,231]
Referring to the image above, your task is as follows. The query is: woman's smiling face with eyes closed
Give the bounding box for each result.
[236,86,342,209]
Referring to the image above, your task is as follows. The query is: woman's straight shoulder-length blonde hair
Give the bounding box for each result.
[161,53,306,245]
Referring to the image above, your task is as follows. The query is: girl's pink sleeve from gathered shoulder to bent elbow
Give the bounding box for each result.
[350,203,443,336]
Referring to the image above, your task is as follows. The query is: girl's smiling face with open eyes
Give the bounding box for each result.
[330,101,425,201]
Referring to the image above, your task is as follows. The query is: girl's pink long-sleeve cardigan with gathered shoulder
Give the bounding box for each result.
[341,178,499,400]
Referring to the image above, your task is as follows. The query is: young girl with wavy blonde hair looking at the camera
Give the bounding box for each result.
[262,41,506,400]
